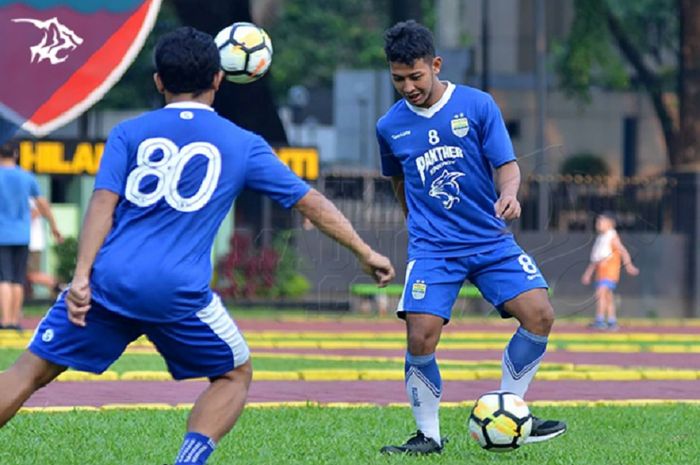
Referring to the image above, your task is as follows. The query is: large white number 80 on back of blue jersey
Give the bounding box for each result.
[126,137,221,212]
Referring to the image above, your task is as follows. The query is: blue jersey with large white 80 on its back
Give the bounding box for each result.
[91,102,309,322]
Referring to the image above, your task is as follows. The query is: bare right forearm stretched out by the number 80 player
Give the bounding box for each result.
[294,189,396,287]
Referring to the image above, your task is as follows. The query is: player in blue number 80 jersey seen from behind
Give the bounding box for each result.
[0,27,394,465]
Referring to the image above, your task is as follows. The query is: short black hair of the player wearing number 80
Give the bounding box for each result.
[153,26,221,94]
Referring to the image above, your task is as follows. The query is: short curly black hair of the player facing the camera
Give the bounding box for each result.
[384,19,435,65]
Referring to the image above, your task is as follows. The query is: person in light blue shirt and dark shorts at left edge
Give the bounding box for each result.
[0,142,63,330]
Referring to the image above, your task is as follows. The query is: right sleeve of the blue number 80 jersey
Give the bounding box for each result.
[245,137,311,208]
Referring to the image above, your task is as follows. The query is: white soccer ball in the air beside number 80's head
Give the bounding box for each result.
[214,22,272,84]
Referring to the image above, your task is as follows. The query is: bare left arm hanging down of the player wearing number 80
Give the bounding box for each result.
[66,189,119,326]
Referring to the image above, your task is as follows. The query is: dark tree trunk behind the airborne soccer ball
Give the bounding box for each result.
[173,0,287,145]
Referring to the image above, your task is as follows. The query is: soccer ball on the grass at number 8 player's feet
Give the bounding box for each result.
[469,391,532,452]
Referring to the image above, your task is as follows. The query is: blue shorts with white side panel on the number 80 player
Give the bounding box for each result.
[29,291,250,379]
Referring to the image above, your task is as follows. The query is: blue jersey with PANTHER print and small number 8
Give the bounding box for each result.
[377,83,515,259]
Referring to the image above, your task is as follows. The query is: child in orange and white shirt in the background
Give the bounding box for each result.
[581,212,639,331]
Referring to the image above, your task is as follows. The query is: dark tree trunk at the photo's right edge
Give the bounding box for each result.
[675,0,700,169]
